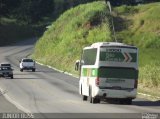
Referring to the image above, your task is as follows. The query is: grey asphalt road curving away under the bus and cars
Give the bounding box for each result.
[0,39,160,118]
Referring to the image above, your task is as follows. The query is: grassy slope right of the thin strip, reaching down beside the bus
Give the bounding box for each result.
[115,2,160,96]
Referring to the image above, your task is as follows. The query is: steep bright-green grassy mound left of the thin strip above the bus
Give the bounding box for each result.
[34,2,111,73]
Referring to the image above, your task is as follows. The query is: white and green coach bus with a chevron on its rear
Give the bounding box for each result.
[75,42,138,104]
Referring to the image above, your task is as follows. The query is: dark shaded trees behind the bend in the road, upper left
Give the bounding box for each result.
[0,0,97,46]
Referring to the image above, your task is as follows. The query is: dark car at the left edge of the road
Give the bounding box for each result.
[0,63,13,79]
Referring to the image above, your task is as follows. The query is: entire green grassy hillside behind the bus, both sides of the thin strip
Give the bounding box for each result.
[33,2,160,95]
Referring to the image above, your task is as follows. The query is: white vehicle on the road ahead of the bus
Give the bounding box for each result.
[19,58,36,72]
